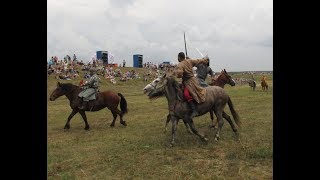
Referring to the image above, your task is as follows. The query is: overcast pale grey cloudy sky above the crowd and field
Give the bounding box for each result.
[47,0,273,71]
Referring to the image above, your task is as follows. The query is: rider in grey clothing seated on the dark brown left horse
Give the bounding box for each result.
[78,68,100,110]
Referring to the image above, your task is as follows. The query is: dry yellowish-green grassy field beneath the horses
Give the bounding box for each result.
[47,68,273,179]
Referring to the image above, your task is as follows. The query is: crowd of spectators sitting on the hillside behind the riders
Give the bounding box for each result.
[47,54,219,87]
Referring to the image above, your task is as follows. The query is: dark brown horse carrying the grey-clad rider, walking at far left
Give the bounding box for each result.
[50,82,128,130]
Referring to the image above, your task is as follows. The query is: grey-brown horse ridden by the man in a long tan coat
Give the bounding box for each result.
[148,75,241,145]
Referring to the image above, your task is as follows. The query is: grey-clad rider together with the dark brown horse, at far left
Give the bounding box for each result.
[50,66,128,130]
